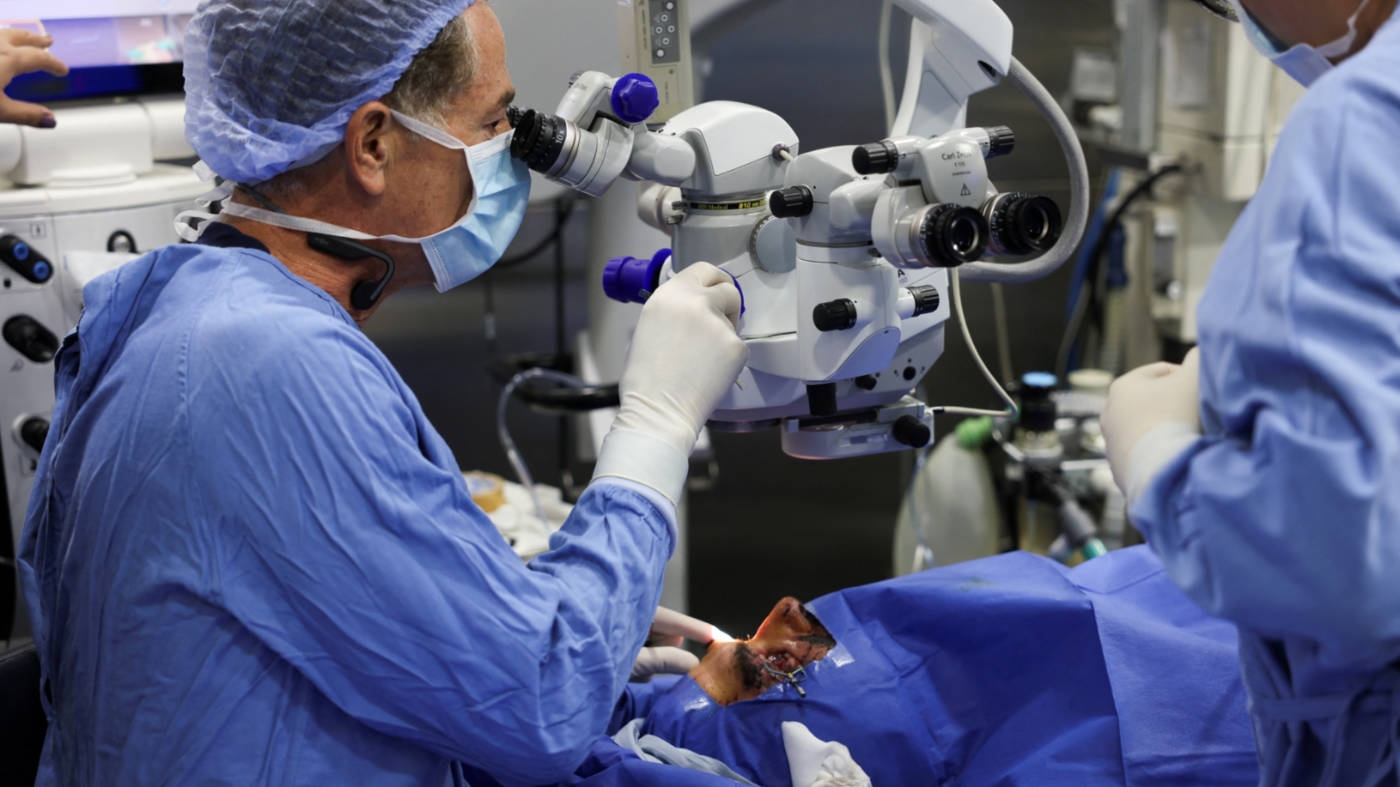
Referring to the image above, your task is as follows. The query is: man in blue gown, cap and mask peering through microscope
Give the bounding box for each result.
[21,0,745,787]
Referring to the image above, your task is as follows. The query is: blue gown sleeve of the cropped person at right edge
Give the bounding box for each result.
[1131,74,1400,667]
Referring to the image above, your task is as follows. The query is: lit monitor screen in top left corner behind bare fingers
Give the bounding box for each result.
[0,0,196,102]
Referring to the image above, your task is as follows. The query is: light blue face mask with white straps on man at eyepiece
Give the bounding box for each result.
[215,112,531,293]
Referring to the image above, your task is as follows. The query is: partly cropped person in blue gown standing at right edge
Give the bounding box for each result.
[1103,0,1400,787]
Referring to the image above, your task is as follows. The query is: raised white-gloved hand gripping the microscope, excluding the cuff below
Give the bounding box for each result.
[613,262,749,457]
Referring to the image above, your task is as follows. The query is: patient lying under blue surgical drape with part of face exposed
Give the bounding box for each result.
[565,549,1259,787]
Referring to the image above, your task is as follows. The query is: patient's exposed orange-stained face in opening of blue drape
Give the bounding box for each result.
[690,598,836,704]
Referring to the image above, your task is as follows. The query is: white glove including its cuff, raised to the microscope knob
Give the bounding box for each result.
[594,262,749,503]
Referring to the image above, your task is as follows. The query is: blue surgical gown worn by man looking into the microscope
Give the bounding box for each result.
[21,228,675,786]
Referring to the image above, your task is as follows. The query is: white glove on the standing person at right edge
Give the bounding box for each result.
[1100,350,1201,503]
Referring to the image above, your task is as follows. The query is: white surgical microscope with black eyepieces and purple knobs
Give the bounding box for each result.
[514,0,1082,458]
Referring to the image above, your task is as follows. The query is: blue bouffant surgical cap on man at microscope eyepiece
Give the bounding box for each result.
[185,0,476,183]
